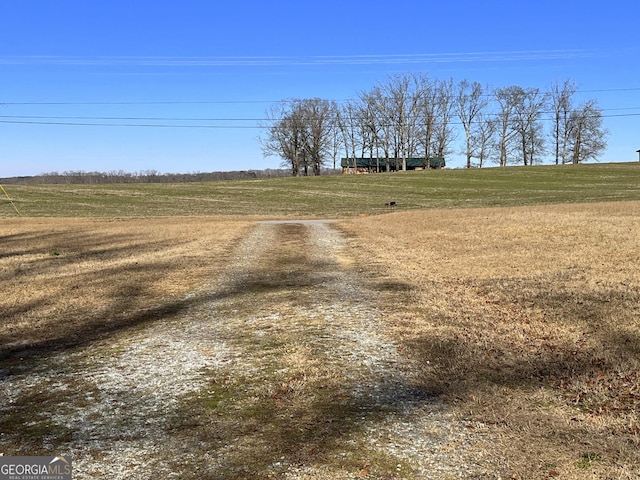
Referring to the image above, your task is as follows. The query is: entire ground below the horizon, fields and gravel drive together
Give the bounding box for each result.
[0,163,640,479]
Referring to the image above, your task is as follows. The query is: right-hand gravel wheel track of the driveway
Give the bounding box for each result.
[288,224,496,479]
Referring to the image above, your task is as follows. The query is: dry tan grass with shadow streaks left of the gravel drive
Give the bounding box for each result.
[0,218,250,358]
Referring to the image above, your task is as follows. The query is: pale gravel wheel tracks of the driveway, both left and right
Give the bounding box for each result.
[0,221,493,479]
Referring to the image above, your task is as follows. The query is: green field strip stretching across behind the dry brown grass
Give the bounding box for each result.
[0,163,640,218]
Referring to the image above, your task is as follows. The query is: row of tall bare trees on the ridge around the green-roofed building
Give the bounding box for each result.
[261,73,607,176]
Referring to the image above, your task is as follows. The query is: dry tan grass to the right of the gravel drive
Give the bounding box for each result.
[344,202,640,479]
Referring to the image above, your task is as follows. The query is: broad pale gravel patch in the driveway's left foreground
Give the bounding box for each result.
[0,312,233,479]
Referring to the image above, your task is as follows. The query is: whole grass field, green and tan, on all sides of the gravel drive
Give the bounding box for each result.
[0,164,640,479]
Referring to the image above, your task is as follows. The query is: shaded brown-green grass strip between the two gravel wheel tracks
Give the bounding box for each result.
[156,225,436,479]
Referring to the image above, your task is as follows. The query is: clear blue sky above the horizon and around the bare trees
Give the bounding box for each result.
[0,0,640,177]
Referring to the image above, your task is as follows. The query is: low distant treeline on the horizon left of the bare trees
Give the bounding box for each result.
[0,168,340,185]
